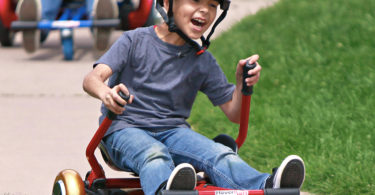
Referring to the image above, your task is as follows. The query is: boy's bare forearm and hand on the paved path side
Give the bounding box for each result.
[83,64,134,114]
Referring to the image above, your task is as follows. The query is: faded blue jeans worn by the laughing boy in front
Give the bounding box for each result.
[104,128,269,195]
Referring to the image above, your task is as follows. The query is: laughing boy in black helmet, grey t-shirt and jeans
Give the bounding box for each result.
[83,0,305,195]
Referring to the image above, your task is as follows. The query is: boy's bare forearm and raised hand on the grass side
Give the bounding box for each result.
[220,55,262,123]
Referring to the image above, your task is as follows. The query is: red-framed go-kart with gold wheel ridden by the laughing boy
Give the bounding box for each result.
[53,63,300,195]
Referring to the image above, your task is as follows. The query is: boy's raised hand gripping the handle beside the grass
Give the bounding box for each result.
[236,54,262,89]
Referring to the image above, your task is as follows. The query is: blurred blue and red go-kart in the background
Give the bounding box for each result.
[0,0,155,60]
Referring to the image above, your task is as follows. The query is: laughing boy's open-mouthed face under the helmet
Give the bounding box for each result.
[168,0,219,39]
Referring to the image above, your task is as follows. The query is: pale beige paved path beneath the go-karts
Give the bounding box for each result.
[0,0,306,195]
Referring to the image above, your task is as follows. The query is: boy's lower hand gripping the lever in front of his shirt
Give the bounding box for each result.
[102,83,134,114]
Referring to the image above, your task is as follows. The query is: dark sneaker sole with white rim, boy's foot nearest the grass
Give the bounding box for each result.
[274,155,305,188]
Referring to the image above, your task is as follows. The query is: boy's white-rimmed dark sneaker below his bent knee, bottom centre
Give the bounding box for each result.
[166,163,197,190]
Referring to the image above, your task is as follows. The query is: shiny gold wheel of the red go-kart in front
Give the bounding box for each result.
[52,169,86,195]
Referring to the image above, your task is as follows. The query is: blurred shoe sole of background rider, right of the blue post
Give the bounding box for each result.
[92,0,119,51]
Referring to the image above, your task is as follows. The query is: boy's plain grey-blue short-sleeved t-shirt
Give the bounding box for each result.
[94,27,235,135]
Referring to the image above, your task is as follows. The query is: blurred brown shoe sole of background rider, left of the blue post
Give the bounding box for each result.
[16,0,41,53]
